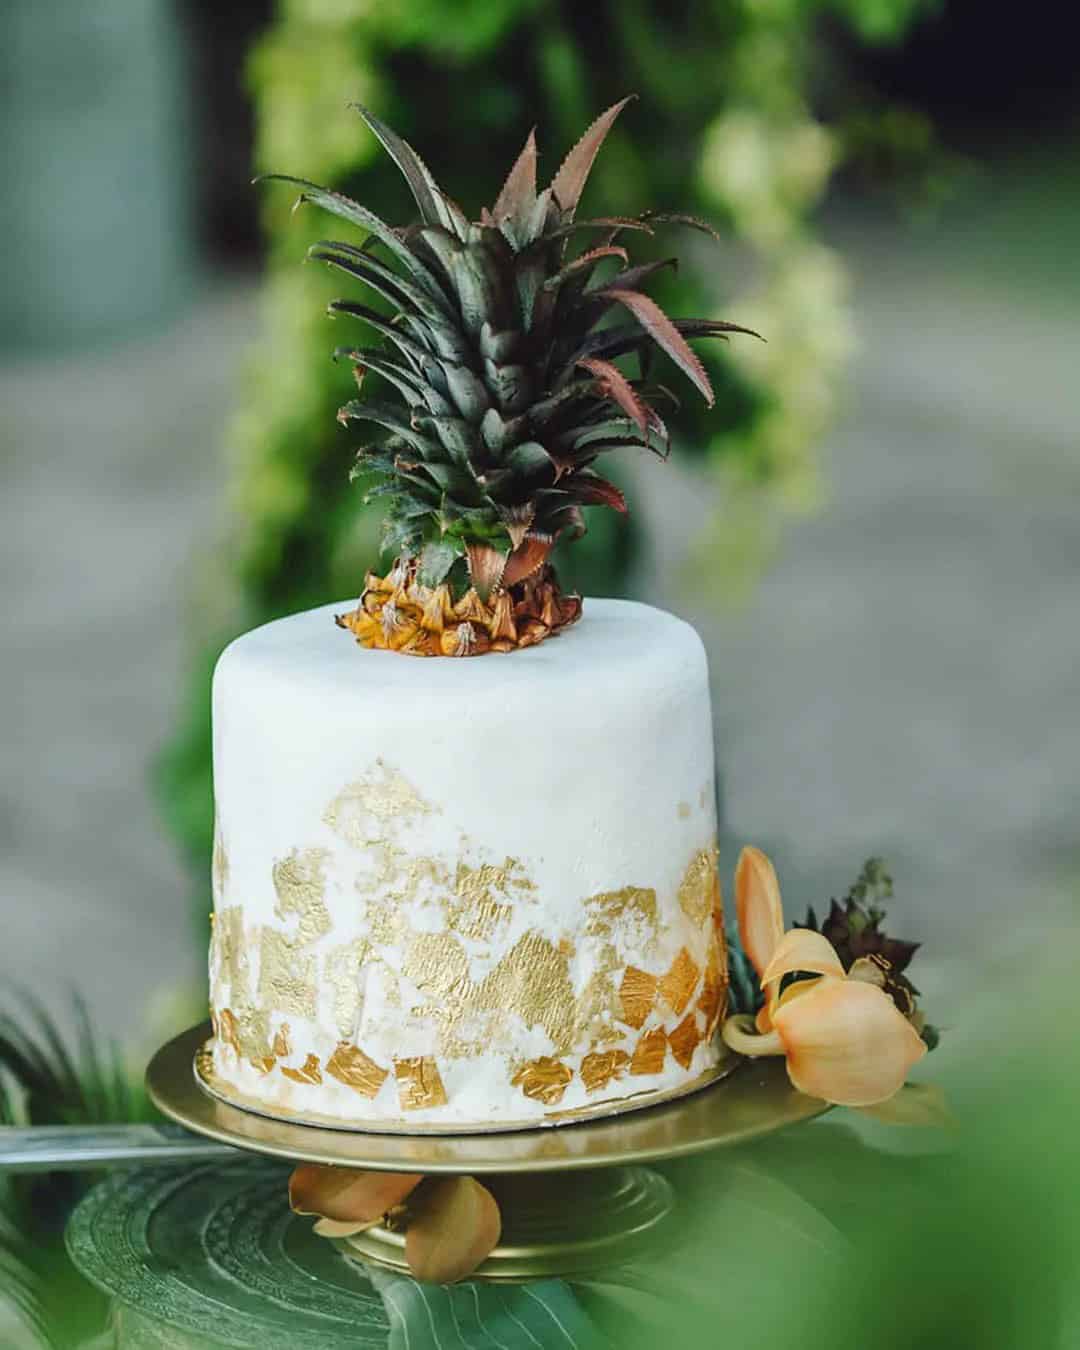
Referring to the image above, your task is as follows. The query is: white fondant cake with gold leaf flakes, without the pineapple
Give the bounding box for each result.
[211,601,726,1130]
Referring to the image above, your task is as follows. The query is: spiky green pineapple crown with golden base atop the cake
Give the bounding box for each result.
[267,99,756,655]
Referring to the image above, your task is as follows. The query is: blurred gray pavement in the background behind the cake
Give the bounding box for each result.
[0,190,1080,1046]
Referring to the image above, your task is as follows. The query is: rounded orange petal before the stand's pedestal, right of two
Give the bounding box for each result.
[405,1176,502,1284]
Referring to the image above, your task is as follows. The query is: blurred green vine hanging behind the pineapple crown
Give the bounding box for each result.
[159,0,934,896]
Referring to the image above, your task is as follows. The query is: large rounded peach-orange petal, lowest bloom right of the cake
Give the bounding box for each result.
[772,975,926,1106]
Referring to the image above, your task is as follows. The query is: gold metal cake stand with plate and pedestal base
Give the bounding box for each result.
[146,1023,829,1280]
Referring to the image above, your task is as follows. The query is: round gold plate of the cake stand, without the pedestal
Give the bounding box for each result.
[146,1022,830,1175]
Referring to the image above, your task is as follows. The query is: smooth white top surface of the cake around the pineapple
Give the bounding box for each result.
[219,599,705,699]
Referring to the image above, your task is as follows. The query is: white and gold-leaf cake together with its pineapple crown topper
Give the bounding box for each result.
[203,104,761,1131]
